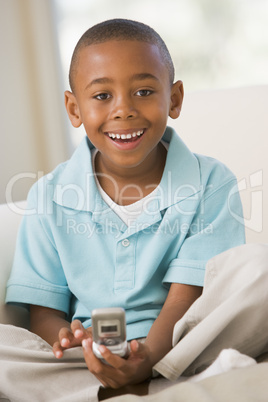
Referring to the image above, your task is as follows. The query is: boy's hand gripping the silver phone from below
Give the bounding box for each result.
[82,338,152,389]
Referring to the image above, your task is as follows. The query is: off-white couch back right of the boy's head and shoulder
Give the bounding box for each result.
[169,85,268,243]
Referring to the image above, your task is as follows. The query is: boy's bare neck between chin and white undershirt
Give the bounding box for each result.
[95,143,167,205]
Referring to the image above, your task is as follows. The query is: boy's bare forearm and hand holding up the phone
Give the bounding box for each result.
[82,283,202,388]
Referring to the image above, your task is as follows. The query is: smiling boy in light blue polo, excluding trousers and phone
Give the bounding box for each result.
[7,20,244,388]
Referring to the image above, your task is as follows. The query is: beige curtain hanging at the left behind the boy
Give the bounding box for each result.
[0,0,68,203]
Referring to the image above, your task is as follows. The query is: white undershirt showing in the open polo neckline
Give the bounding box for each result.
[91,141,169,226]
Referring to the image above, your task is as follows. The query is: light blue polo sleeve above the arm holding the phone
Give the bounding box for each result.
[163,179,245,286]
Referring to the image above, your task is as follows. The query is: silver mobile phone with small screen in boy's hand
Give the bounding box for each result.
[91,307,128,360]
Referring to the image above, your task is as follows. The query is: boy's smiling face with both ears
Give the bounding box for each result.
[65,40,183,174]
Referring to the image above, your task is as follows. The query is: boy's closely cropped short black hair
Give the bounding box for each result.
[69,18,175,92]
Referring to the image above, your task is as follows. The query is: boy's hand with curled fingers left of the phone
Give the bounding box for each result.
[53,320,92,359]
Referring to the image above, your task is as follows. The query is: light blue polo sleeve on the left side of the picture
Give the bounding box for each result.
[6,184,71,314]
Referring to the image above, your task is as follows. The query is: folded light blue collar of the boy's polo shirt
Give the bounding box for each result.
[53,127,201,215]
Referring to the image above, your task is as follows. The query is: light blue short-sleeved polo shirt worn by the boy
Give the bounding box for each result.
[6,128,245,339]
